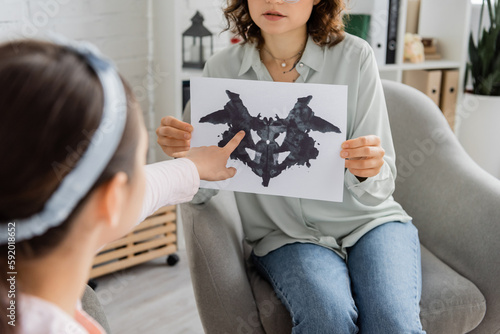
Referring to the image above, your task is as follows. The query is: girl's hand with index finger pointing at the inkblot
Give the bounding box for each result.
[172,131,245,181]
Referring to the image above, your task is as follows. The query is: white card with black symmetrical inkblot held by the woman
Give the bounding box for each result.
[191,78,347,202]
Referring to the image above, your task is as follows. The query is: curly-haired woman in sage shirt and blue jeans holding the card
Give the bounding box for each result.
[157,0,423,334]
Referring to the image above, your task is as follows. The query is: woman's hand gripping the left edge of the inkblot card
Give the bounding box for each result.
[156,116,193,157]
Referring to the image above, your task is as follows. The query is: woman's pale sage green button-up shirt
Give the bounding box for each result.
[191,34,411,257]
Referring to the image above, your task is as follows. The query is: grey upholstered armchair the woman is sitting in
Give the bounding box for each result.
[181,81,500,334]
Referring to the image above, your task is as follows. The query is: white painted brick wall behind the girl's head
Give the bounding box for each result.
[0,0,156,161]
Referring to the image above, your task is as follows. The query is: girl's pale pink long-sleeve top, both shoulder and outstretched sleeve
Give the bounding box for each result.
[17,159,200,334]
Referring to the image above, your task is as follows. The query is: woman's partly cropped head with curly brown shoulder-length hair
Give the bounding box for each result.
[224,0,345,46]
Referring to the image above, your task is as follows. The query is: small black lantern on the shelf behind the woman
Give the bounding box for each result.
[182,11,214,68]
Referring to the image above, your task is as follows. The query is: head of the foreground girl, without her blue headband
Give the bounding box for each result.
[0,41,147,271]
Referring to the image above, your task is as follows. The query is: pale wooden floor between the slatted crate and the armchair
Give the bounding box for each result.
[96,251,203,334]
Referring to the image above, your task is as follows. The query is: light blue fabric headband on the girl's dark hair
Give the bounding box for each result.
[0,36,127,245]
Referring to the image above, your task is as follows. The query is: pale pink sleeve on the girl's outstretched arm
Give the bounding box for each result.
[137,159,200,224]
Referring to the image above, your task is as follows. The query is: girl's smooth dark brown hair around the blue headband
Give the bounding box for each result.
[0,40,139,333]
